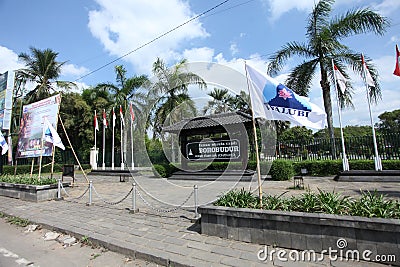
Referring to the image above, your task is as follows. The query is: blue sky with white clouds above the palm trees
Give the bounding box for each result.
[0,0,400,129]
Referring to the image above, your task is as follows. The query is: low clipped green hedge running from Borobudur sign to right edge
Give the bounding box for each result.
[153,160,400,180]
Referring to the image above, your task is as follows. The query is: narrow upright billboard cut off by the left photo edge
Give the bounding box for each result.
[0,71,14,130]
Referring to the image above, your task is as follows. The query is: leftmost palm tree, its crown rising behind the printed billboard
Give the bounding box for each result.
[18,47,76,103]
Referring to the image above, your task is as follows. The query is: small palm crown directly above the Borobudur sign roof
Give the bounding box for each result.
[203,88,234,114]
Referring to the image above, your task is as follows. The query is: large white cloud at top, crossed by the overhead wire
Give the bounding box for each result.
[88,0,208,73]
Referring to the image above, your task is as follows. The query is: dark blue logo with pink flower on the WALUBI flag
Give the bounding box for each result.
[263,83,312,111]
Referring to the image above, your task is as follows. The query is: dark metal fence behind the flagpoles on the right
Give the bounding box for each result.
[268,133,400,161]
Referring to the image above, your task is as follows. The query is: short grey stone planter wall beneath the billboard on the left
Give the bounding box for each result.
[0,183,69,202]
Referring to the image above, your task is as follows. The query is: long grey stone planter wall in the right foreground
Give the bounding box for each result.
[199,205,400,266]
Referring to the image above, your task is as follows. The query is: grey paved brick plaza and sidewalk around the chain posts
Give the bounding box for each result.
[0,172,400,266]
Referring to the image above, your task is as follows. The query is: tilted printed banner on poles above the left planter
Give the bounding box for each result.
[16,95,61,158]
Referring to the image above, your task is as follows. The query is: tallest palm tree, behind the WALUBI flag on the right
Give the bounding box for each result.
[267,0,389,144]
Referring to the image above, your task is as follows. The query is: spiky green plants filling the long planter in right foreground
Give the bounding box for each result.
[214,189,400,219]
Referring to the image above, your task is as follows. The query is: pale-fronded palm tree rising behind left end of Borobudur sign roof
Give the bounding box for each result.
[152,58,207,137]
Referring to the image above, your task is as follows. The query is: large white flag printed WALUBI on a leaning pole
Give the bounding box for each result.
[246,64,326,129]
